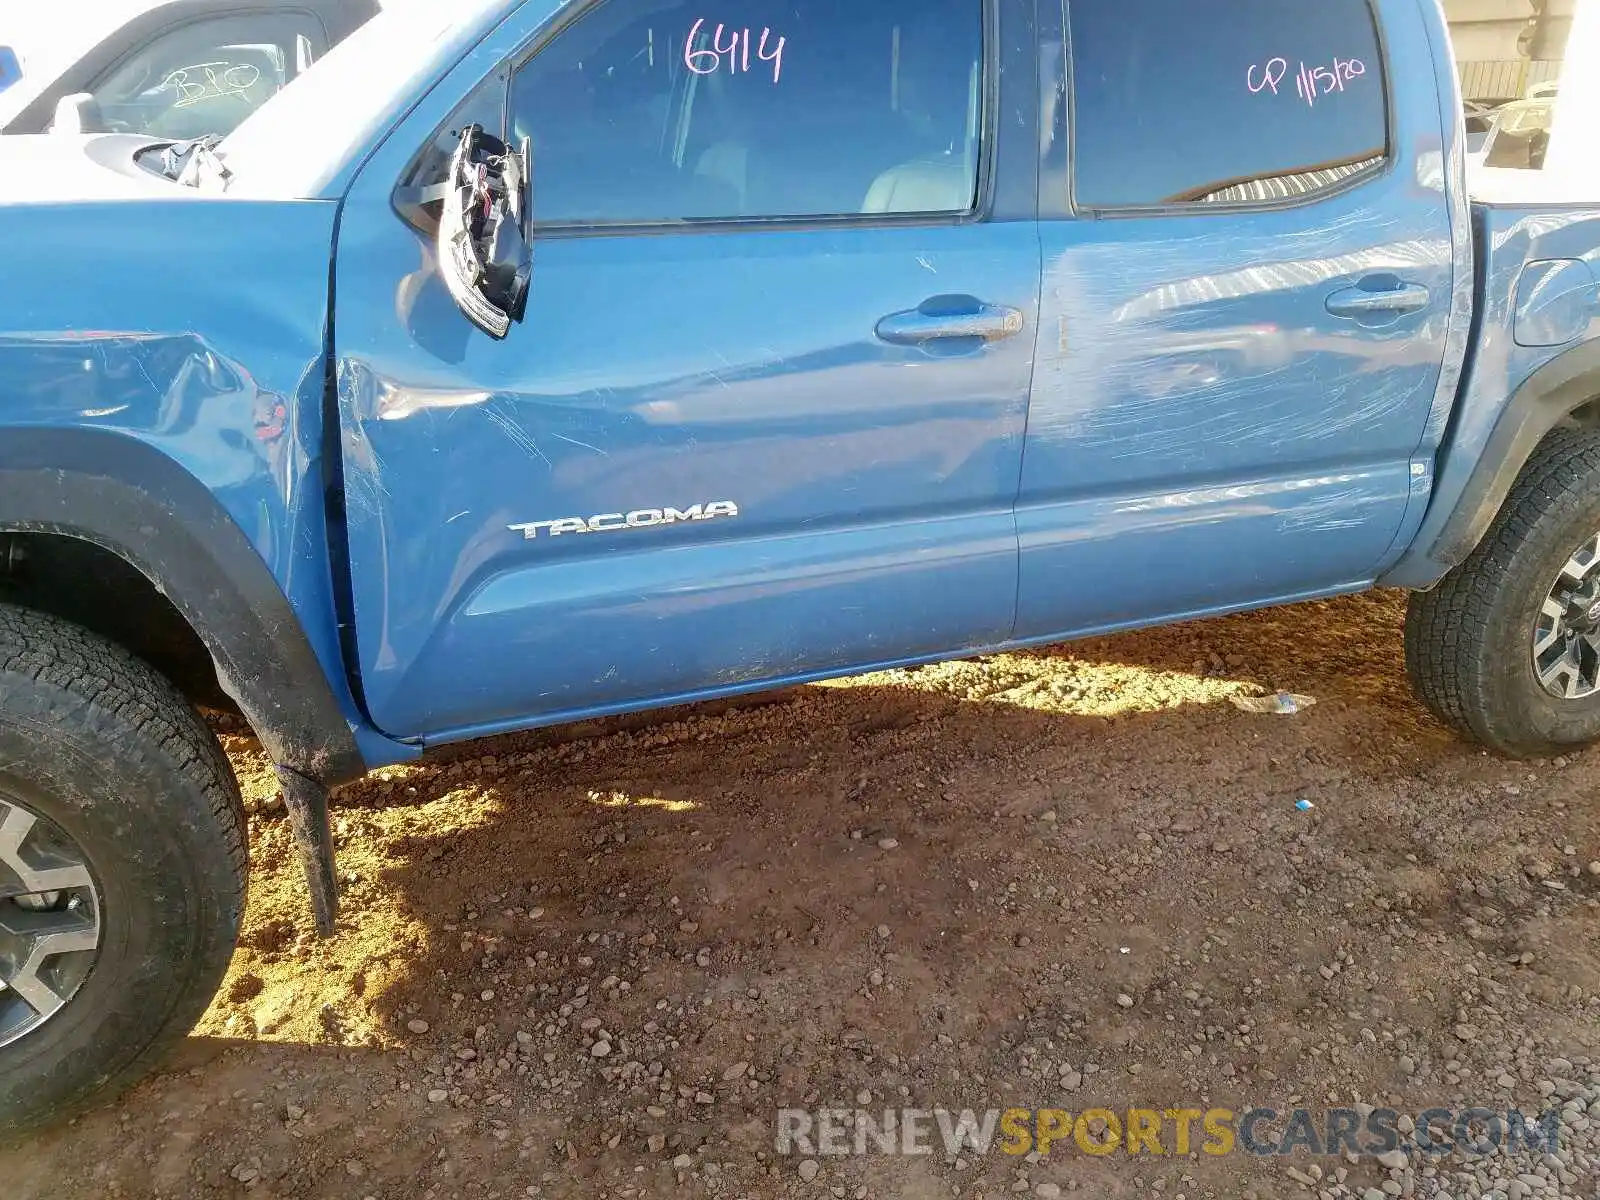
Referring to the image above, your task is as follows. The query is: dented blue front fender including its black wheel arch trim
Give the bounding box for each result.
[0,197,406,782]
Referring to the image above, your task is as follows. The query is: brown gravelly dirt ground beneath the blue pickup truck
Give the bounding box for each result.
[0,594,1600,1200]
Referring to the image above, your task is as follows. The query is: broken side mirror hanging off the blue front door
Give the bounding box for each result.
[437,125,533,338]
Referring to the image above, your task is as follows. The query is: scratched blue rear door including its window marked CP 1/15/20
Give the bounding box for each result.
[1018,0,1454,637]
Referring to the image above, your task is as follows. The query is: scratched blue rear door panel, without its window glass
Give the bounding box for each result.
[1016,3,1470,638]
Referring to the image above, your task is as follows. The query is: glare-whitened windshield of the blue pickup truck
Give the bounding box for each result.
[218,0,522,198]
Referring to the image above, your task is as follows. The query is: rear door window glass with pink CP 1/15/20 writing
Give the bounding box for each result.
[1069,0,1389,211]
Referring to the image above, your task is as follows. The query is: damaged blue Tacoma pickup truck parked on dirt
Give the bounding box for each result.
[0,0,1600,1130]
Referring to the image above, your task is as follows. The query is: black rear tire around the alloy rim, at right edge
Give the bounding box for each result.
[1405,429,1600,758]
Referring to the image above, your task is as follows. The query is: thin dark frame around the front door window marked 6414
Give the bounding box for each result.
[492,0,1013,242]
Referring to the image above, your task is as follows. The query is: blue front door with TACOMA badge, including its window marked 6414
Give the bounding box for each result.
[334,0,1038,738]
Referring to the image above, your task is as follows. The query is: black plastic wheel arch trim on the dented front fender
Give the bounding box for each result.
[0,427,365,786]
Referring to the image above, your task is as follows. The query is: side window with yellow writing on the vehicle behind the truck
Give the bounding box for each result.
[90,11,328,139]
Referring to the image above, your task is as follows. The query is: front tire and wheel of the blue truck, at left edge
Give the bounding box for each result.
[0,605,246,1141]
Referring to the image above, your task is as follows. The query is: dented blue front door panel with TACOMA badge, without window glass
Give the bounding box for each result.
[334,0,1040,741]
